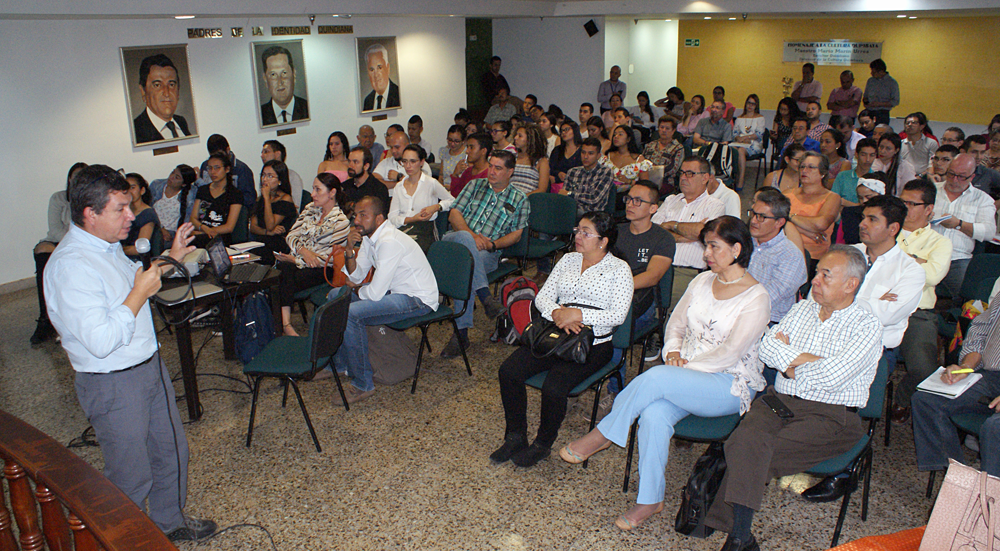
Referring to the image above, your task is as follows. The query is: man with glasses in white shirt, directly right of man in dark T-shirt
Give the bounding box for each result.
[653,156,726,309]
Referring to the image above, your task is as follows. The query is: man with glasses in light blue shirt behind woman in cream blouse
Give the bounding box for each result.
[747,187,806,323]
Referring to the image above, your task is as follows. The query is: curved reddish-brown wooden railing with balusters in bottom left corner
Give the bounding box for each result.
[0,410,177,551]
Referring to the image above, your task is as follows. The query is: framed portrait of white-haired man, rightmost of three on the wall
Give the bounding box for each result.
[357,36,400,113]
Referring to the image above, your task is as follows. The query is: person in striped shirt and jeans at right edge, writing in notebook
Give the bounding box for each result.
[912,303,1000,476]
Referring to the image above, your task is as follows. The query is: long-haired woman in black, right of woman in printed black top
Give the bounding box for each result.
[250,161,298,264]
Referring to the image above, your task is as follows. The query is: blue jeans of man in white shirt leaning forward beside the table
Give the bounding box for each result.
[330,288,431,392]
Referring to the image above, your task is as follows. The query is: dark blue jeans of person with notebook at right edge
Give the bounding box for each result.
[910,371,1000,476]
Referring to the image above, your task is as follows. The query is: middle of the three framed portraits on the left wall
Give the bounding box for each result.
[250,40,309,128]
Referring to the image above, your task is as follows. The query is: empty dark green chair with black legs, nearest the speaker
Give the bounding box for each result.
[243,287,351,452]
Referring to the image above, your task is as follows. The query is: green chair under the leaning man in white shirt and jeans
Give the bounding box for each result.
[386,241,475,394]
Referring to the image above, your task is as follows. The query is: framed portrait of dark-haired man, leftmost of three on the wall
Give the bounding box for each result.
[120,44,198,147]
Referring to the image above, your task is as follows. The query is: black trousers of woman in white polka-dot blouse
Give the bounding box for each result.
[499,341,614,448]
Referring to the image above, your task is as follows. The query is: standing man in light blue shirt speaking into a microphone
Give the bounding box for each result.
[44,165,216,541]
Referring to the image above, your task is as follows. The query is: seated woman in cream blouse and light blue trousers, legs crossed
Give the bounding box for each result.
[559,216,771,530]
